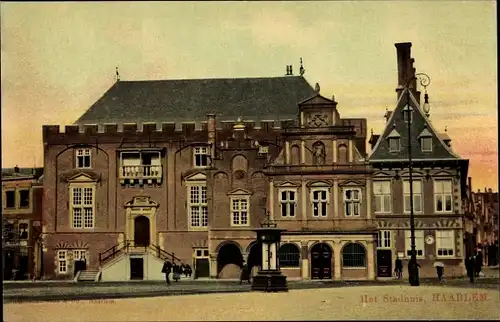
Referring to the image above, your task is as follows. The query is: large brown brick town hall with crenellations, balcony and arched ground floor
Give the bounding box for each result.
[43,68,376,280]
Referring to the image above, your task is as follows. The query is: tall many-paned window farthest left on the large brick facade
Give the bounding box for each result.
[71,187,94,228]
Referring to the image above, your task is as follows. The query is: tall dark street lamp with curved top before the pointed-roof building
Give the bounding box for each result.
[403,73,431,286]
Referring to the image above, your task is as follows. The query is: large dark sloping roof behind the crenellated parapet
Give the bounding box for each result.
[75,76,315,125]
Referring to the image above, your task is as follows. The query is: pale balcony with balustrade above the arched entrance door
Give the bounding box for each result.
[119,152,163,185]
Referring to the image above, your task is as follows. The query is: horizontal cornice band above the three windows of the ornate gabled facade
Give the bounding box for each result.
[265,164,372,174]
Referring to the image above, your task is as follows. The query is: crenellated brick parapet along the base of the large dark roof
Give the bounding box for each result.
[43,120,297,144]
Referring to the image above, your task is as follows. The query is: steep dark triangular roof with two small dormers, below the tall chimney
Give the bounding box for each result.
[368,89,461,161]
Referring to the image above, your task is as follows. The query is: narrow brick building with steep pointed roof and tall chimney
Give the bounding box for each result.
[368,43,468,276]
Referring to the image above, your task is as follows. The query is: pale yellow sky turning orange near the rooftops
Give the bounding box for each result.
[0,0,498,191]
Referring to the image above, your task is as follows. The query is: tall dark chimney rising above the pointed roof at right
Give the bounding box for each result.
[395,42,420,103]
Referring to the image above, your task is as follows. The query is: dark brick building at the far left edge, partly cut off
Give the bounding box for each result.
[2,167,43,280]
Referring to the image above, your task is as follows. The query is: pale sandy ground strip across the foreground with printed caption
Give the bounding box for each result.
[4,285,500,322]
